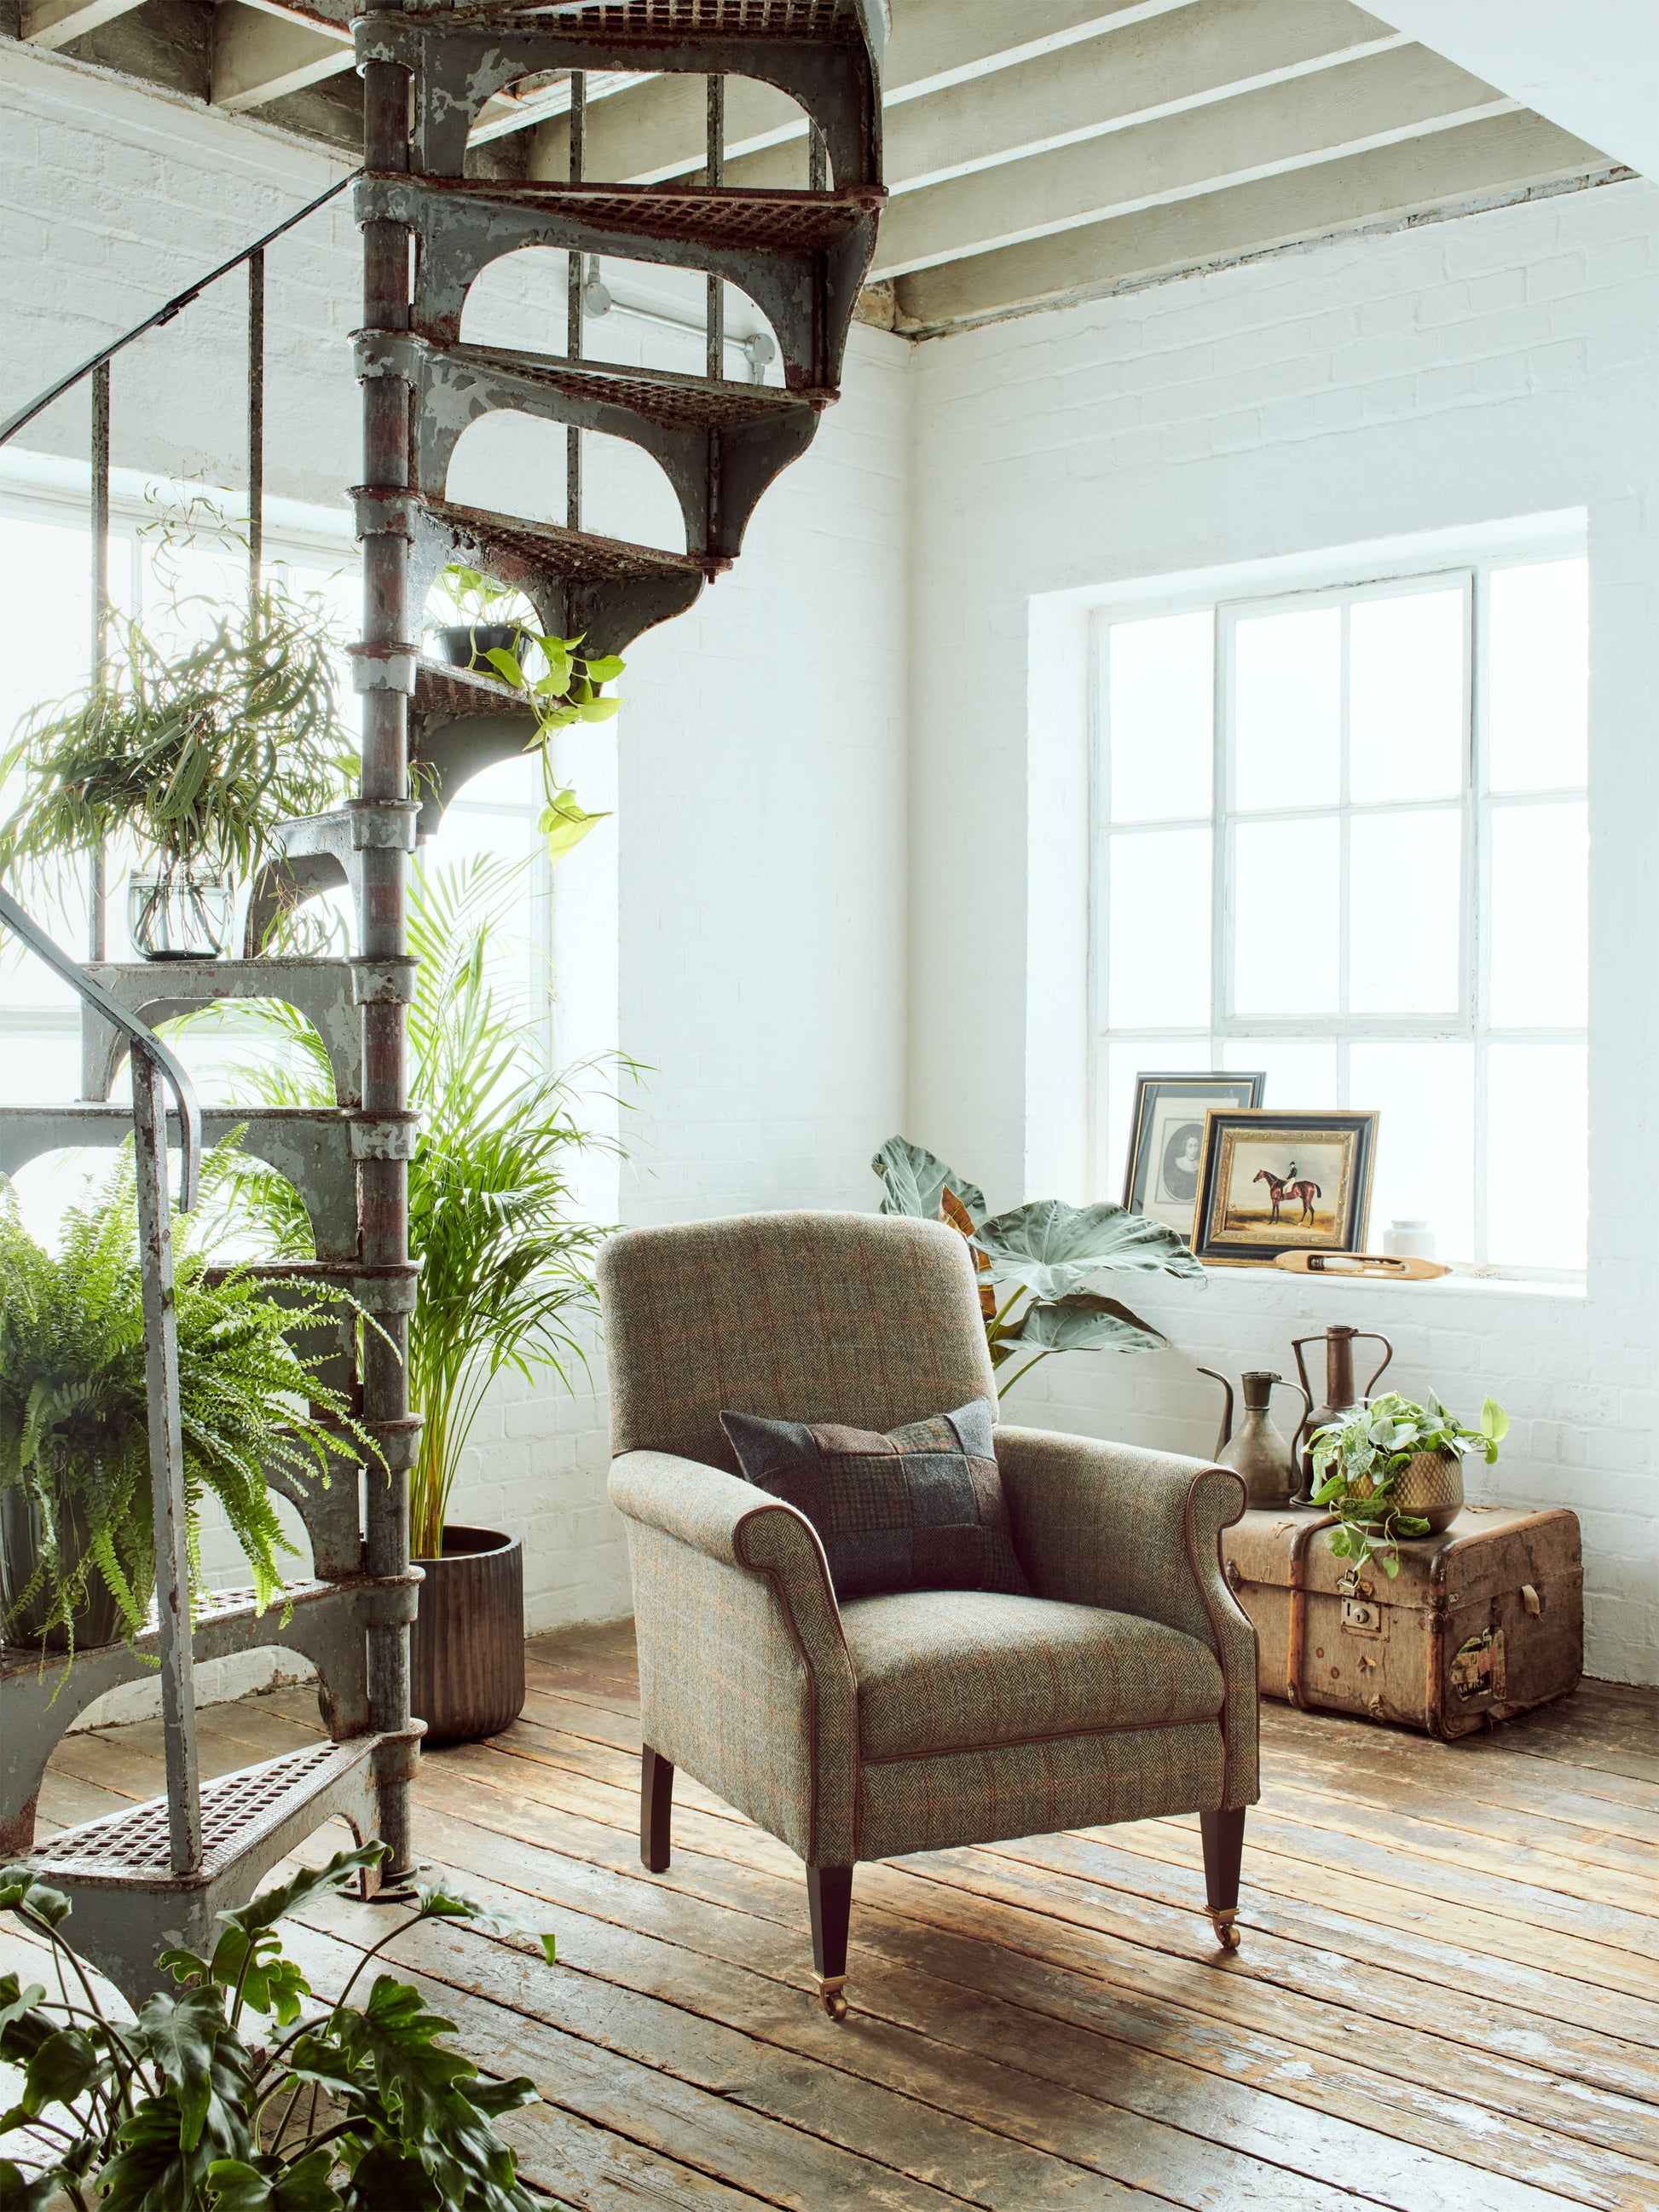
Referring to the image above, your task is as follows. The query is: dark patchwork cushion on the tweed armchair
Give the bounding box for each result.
[721,1398,1031,1599]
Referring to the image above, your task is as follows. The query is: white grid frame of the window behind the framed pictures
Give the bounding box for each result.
[1089,528,1588,1283]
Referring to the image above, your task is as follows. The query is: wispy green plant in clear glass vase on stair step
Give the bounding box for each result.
[0,516,356,960]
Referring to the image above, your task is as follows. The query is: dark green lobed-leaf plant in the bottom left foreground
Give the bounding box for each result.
[0,1843,553,2212]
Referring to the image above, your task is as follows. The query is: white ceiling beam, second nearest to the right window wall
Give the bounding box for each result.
[871,46,1515,276]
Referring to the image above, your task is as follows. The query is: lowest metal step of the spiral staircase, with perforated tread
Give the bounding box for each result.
[26,1724,420,2001]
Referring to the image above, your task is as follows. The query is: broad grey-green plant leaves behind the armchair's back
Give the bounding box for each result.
[871,1137,1203,1395]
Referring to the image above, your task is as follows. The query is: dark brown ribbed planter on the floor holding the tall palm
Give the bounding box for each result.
[409,1528,524,1743]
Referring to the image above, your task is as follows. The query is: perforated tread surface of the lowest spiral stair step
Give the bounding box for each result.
[29,1736,383,1889]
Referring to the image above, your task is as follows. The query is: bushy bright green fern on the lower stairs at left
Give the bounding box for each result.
[0,1148,373,1635]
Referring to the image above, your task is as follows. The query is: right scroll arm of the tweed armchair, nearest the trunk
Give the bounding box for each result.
[996,1429,1257,1805]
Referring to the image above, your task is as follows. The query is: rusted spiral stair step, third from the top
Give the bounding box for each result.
[373,334,836,560]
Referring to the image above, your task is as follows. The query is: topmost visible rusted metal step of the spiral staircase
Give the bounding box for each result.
[356,0,887,183]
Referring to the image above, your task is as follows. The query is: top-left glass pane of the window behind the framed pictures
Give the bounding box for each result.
[1106,609,1214,823]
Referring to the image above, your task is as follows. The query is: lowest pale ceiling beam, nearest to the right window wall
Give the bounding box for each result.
[893,111,1608,332]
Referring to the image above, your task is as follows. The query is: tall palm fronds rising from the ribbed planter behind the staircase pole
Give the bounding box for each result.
[202,858,619,1559]
